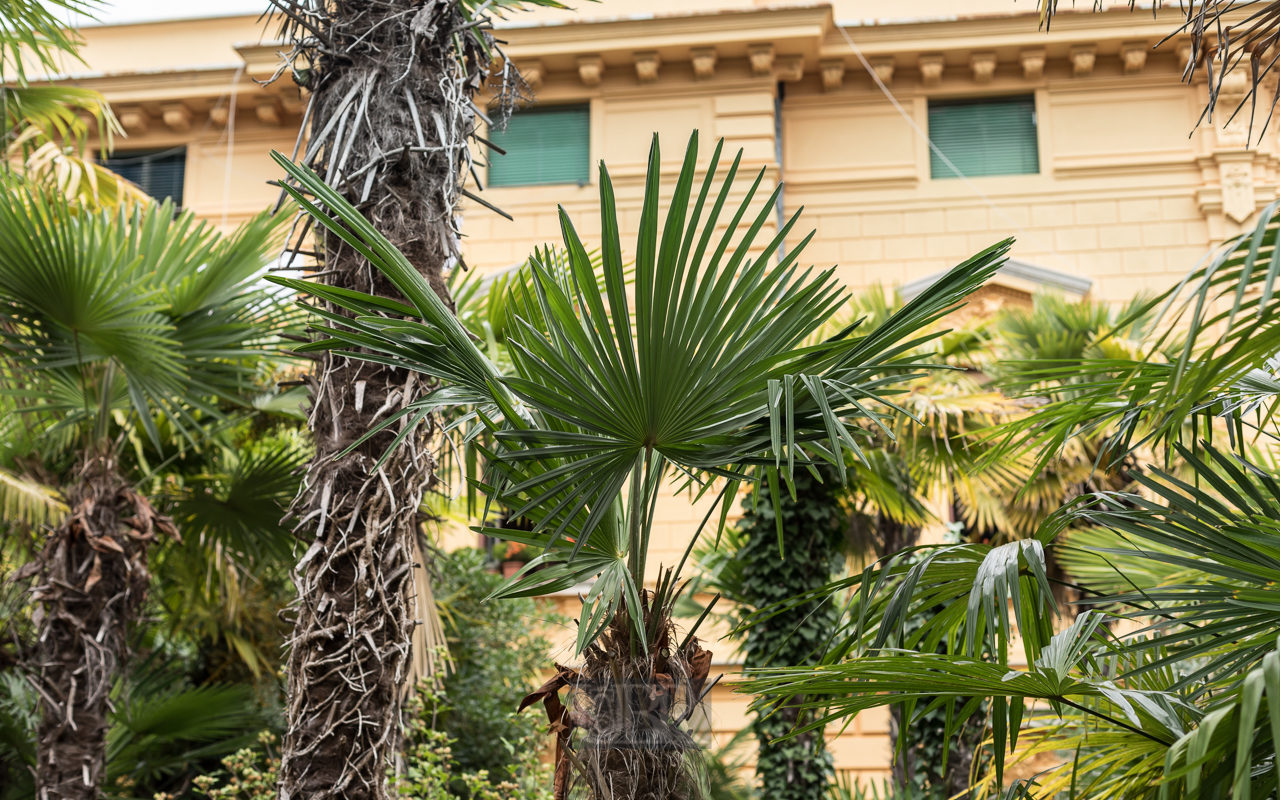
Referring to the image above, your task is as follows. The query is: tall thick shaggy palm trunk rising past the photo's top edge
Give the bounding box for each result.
[275,0,514,800]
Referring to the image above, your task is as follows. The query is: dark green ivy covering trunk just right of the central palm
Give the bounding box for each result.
[736,467,846,800]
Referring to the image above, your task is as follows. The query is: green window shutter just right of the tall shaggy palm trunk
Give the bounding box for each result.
[489,105,591,186]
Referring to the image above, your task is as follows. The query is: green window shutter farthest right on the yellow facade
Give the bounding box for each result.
[929,96,1039,179]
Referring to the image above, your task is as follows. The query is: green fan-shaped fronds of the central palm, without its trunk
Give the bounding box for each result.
[275,133,1010,639]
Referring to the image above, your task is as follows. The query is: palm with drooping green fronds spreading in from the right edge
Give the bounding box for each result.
[753,200,1280,799]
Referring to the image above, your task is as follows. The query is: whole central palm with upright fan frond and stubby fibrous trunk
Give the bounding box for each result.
[275,133,1009,800]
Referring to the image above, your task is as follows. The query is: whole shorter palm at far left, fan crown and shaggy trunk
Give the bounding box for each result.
[0,182,284,797]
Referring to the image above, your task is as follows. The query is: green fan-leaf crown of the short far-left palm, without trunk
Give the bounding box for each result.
[0,189,288,447]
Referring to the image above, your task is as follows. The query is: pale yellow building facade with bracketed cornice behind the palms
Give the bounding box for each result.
[40,0,1259,777]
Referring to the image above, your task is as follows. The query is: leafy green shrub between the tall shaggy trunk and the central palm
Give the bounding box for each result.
[433,549,562,781]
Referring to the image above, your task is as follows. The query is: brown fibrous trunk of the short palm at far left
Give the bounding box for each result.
[31,456,177,800]
